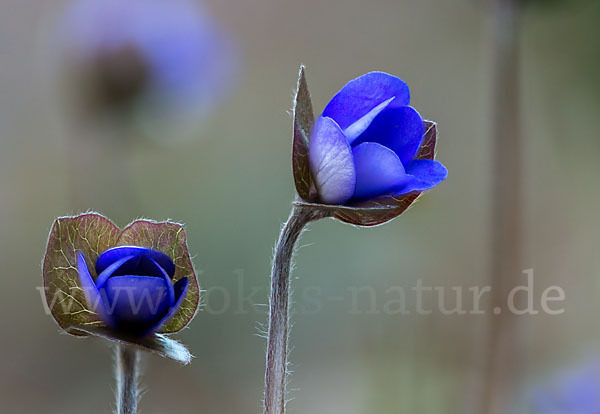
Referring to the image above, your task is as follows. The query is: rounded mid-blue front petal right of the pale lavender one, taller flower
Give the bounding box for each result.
[352,142,409,199]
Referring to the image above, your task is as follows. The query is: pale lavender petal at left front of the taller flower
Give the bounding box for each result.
[308,117,356,204]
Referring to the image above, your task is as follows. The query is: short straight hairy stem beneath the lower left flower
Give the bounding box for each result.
[115,345,139,414]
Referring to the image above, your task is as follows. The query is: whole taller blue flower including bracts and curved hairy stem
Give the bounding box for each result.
[263,66,447,414]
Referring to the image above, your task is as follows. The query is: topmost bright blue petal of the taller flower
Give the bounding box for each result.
[323,72,410,130]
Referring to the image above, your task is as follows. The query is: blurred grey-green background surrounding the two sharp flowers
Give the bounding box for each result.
[0,0,600,414]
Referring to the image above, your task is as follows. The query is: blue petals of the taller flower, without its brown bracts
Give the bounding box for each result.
[308,72,448,205]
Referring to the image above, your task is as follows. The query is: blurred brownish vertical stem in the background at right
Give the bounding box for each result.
[480,0,522,414]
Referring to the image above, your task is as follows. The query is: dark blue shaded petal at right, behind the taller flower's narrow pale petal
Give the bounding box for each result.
[354,106,425,166]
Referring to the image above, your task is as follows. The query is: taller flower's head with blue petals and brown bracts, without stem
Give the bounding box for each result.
[292,67,448,226]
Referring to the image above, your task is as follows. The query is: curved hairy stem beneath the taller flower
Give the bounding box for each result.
[264,206,327,414]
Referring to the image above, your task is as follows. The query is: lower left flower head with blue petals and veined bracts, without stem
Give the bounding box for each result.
[43,213,199,362]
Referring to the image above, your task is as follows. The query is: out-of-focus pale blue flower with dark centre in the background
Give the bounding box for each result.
[61,0,236,131]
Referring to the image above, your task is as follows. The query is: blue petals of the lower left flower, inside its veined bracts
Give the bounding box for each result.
[77,246,189,337]
